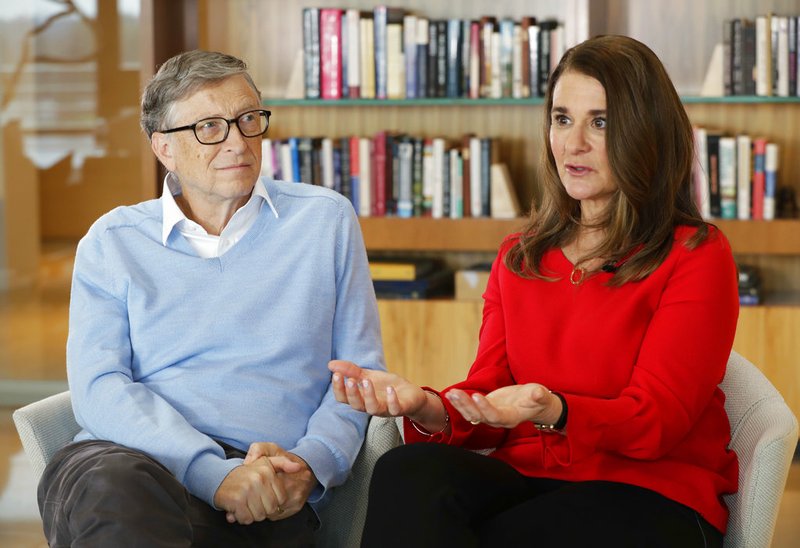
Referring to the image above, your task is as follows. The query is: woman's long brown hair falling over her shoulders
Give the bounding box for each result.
[505,36,708,286]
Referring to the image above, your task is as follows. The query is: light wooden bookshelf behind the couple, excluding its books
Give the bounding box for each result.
[170,0,800,415]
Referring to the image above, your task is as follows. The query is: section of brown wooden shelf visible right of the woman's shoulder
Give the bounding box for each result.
[712,219,800,255]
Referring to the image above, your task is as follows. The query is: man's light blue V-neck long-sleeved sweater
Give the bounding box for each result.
[67,180,385,506]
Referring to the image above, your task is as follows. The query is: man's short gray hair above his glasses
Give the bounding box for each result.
[141,50,261,139]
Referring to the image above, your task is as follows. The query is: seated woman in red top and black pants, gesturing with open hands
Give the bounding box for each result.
[330,36,738,547]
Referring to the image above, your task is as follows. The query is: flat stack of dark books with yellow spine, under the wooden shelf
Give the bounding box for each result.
[369,258,453,299]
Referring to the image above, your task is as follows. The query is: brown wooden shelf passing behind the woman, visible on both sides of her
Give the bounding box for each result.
[359,217,800,255]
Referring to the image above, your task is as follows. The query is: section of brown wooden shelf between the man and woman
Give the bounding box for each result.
[359,217,526,251]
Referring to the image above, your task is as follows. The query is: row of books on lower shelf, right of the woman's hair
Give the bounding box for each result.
[693,127,780,220]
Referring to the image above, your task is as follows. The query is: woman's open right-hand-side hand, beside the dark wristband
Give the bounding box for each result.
[445,383,561,428]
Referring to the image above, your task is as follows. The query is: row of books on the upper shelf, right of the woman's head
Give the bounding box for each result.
[722,14,800,97]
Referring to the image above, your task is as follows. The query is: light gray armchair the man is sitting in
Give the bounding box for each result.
[14,392,400,548]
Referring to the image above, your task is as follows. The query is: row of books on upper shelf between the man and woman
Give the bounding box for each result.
[303,5,566,99]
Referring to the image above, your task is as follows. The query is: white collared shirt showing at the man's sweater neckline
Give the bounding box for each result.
[161,173,278,259]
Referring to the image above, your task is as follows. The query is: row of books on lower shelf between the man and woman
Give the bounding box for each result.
[261,131,521,219]
